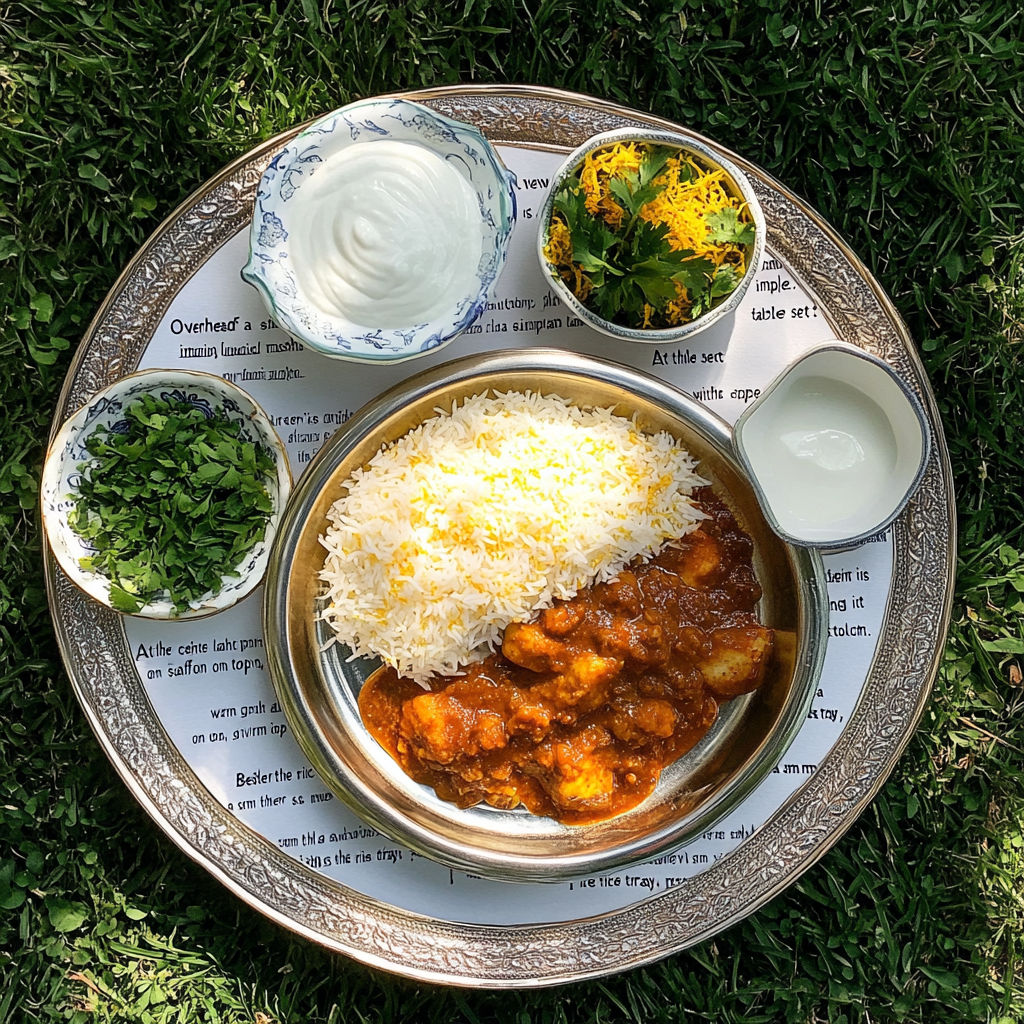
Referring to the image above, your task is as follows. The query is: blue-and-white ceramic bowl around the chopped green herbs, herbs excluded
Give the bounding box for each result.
[40,370,292,618]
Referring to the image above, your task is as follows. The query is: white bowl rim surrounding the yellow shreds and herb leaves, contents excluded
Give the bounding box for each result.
[537,128,766,345]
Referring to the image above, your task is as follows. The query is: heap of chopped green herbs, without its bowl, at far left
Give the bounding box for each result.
[69,394,274,613]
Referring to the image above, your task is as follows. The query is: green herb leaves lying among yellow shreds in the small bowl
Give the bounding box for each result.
[554,146,754,327]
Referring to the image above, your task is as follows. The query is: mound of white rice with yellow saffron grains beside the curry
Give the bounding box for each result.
[321,392,707,683]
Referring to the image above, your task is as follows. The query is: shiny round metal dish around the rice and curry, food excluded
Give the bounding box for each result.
[263,349,827,882]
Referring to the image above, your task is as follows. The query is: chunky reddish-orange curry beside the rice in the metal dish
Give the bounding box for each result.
[359,488,773,824]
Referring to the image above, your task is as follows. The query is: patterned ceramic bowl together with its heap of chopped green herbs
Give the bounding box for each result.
[40,370,292,618]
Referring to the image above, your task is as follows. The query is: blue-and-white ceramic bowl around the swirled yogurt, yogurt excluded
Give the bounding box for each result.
[242,98,516,362]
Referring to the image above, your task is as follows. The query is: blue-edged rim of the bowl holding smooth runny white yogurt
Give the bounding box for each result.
[732,341,932,552]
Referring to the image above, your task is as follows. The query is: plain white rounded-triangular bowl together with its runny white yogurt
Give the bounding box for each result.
[733,343,930,547]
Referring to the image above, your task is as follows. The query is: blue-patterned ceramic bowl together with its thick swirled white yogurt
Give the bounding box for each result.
[242,99,516,362]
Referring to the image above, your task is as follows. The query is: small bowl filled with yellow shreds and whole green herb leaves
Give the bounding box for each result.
[538,128,765,343]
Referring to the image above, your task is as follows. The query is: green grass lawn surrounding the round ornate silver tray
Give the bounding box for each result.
[0,0,1024,1024]
